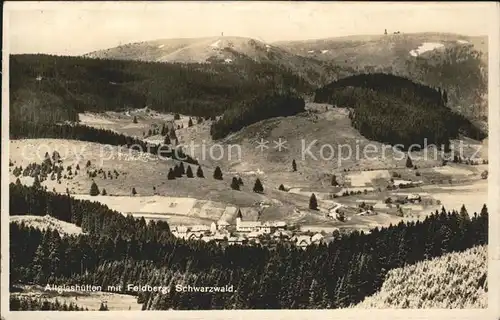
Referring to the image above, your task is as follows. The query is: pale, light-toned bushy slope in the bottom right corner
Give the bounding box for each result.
[356,246,488,308]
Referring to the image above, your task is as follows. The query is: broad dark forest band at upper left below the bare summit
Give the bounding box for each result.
[10,54,312,123]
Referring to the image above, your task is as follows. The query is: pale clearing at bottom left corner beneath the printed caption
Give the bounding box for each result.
[11,286,142,311]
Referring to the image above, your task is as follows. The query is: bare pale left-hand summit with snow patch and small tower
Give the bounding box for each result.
[86,37,346,85]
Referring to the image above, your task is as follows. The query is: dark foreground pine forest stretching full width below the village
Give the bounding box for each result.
[10,184,488,310]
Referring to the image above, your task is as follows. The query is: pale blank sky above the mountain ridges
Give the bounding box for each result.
[4,1,496,55]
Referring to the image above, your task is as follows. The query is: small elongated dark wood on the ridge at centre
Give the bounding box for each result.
[210,94,305,140]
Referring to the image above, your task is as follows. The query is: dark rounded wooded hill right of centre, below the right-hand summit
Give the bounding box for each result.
[314,73,486,149]
